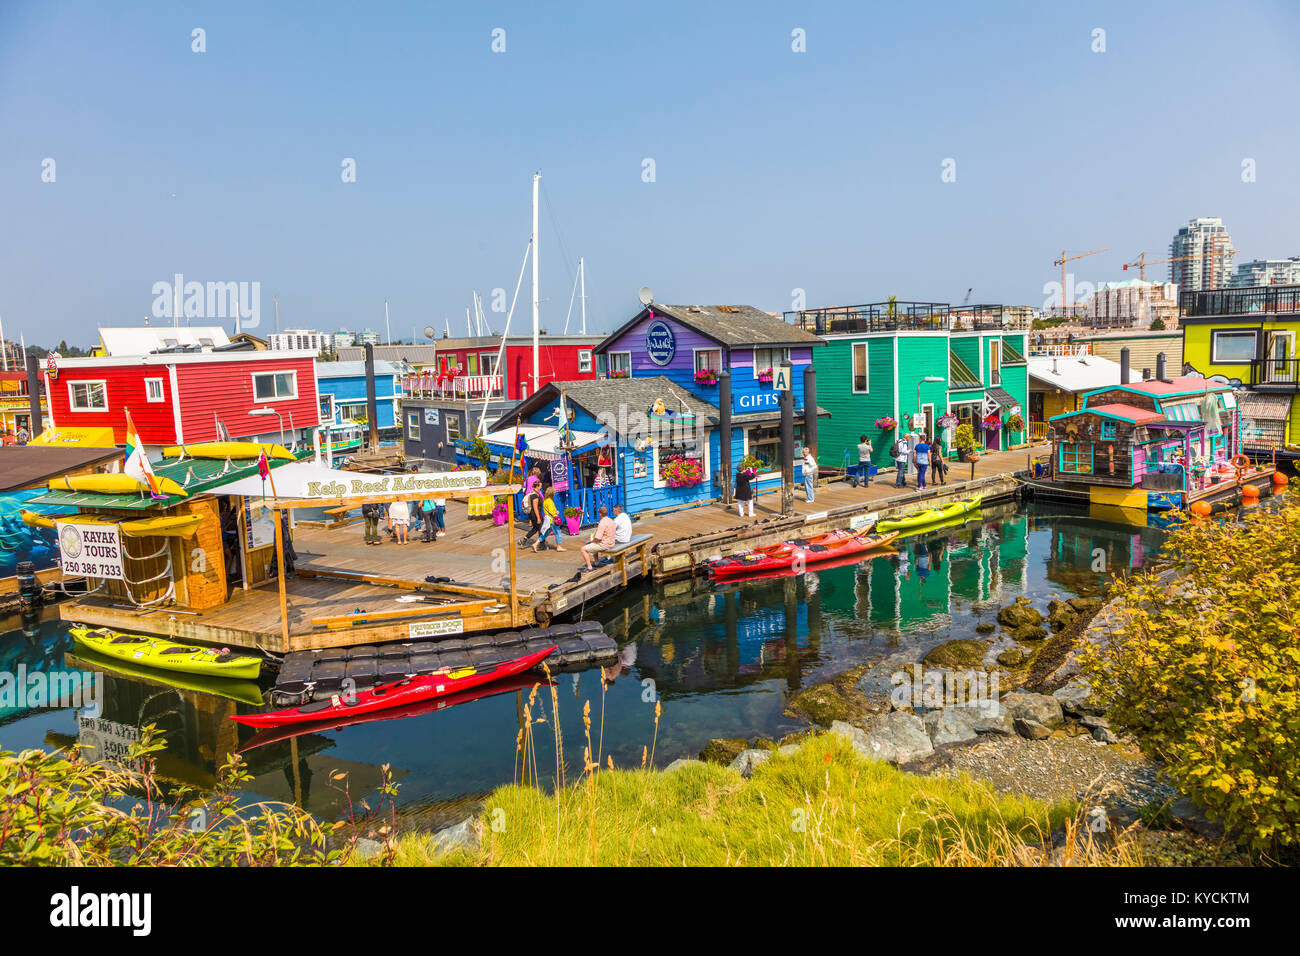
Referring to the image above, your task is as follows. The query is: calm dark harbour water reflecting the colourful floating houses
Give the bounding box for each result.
[0,505,1164,823]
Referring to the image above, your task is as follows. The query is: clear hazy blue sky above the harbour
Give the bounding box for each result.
[0,0,1300,345]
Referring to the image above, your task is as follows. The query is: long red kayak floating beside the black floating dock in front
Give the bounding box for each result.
[230,644,559,727]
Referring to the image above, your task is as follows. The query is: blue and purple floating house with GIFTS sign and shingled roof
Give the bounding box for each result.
[486,304,827,522]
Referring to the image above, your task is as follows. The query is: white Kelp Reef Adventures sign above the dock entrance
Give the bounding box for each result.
[208,462,488,503]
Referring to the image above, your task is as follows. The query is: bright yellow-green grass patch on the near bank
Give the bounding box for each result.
[382,735,1139,866]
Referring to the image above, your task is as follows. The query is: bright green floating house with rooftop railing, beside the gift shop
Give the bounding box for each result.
[785,300,1030,468]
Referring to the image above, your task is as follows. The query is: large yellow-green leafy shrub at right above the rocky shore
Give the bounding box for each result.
[1087,496,1300,849]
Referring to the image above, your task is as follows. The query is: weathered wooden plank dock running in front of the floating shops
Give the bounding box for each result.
[60,445,1048,654]
